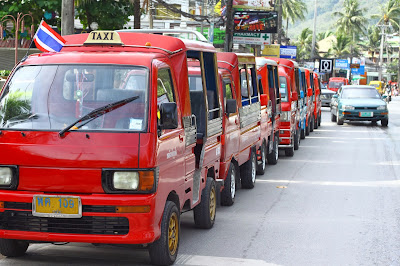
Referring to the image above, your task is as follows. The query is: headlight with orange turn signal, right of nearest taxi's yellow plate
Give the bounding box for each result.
[102,168,158,194]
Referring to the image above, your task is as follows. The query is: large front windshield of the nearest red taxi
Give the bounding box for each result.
[0,65,149,131]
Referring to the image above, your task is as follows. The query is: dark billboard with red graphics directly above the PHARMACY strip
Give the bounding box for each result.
[233,11,278,33]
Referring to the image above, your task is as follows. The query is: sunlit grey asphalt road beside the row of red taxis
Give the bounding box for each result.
[0,97,400,266]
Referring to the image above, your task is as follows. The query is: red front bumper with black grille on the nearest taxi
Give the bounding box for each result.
[0,191,160,244]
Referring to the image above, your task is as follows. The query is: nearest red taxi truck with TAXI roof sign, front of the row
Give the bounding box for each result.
[0,31,225,265]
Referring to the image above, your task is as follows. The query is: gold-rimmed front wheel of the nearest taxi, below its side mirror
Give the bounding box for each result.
[149,201,180,265]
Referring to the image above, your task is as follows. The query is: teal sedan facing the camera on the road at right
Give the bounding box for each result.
[331,85,389,127]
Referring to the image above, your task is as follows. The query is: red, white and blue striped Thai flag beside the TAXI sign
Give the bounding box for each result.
[33,20,65,52]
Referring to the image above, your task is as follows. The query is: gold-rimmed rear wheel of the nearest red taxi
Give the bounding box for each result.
[193,177,217,229]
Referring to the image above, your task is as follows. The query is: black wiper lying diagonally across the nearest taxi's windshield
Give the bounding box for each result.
[58,96,139,137]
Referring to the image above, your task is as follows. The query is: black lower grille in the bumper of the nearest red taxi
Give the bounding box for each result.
[0,210,129,235]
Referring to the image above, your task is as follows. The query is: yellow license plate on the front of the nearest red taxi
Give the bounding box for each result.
[32,195,82,218]
